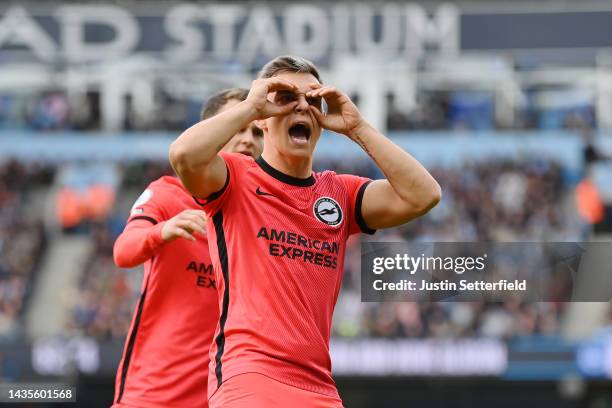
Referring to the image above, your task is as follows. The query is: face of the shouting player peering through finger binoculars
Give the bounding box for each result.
[262,72,321,158]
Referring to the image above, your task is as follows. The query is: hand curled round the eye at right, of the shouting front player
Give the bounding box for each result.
[306,84,365,137]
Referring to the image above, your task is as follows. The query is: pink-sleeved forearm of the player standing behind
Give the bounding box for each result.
[113,220,164,268]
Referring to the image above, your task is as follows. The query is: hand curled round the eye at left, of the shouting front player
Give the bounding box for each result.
[245,77,297,120]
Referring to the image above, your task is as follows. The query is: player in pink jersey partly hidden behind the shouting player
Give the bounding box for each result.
[114,89,262,408]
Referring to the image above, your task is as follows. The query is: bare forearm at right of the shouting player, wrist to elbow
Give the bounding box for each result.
[350,123,441,209]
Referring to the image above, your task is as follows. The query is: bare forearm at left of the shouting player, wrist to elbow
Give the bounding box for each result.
[170,101,256,176]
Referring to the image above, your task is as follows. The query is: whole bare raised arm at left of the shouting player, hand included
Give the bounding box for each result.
[170,78,297,198]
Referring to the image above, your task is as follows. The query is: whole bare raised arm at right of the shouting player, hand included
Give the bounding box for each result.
[308,84,442,229]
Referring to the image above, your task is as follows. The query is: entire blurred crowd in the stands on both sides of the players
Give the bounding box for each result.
[0,158,579,340]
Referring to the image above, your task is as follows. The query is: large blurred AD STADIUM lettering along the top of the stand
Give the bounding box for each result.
[0,3,459,68]
